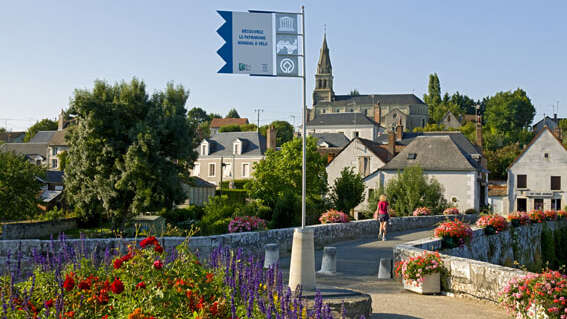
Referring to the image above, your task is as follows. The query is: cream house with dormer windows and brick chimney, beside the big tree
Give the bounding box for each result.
[191,127,276,186]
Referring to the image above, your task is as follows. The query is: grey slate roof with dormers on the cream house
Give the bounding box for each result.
[200,132,266,158]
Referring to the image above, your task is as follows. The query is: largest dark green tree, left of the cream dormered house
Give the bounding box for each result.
[65,78,197,227]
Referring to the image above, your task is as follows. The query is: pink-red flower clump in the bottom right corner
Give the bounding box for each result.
[501,270,567,319]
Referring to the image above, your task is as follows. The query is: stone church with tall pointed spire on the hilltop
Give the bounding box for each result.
[309,34,429,131]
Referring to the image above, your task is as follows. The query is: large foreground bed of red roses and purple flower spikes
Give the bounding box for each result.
[0,237,338,319]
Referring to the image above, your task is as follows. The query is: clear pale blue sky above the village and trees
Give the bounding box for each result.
[0,0,567,131]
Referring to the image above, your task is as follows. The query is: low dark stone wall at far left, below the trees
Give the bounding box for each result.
[2,218,77,240]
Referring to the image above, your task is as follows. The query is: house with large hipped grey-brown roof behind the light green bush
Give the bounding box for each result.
[364,132,488,211]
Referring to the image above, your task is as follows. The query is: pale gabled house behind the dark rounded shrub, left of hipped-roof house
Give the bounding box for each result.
[327,137,391,186]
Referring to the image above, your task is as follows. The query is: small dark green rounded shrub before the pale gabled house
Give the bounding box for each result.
[330,167,364,214]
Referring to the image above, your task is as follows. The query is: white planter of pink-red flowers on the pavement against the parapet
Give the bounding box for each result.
[395,251,444,294]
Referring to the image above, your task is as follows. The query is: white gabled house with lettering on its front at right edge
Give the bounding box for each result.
[508,127,567,211]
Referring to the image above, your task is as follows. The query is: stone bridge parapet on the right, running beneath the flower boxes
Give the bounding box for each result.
[394,221,567,302]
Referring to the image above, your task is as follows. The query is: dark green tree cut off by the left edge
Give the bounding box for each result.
[0,152,45,221]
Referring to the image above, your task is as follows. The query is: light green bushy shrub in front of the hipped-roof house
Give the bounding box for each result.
[386,166,447,216]
